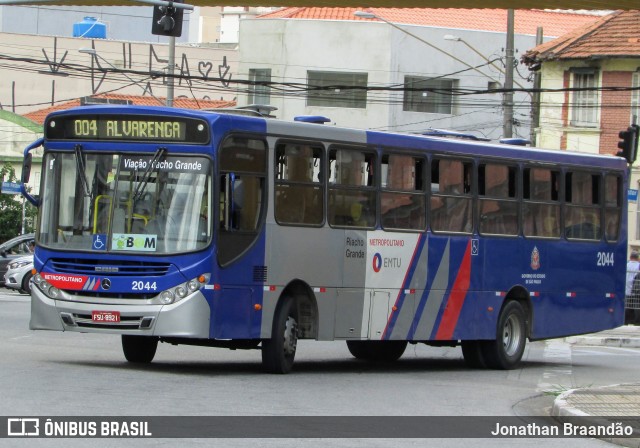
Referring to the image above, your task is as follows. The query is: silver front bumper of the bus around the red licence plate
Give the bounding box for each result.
[29,287,211,339]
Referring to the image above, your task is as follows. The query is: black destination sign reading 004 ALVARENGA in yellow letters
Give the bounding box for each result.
[45,115,209,144]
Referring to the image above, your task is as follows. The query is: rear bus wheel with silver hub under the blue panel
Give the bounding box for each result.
[482,300,527,370]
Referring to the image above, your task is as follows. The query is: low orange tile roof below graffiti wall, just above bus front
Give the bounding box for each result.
[24,93,236,124]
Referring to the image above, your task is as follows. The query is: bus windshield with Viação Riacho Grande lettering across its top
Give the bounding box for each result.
[39,151,213,254]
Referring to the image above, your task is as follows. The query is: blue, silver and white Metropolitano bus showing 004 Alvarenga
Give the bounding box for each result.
[23,105,627,373]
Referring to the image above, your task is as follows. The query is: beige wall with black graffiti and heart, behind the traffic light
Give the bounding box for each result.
[0,33,238,114]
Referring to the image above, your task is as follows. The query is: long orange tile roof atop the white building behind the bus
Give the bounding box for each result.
[258,7,600,36]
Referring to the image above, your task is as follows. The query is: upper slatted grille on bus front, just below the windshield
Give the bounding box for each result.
[51,258,171,277]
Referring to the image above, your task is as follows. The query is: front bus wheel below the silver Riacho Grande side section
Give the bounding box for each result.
[262,297,298,373]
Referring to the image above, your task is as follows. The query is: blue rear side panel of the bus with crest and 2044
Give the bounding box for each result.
[468,238,625,339]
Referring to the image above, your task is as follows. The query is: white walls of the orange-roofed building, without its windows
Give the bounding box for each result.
[239,19,535,138]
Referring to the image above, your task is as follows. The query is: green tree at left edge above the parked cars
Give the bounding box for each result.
[0,162,36,242]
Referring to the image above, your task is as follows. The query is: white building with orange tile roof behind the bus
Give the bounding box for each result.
[239,8,597,139]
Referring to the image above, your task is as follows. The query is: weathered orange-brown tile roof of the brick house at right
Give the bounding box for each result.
[523,10,640,63]
